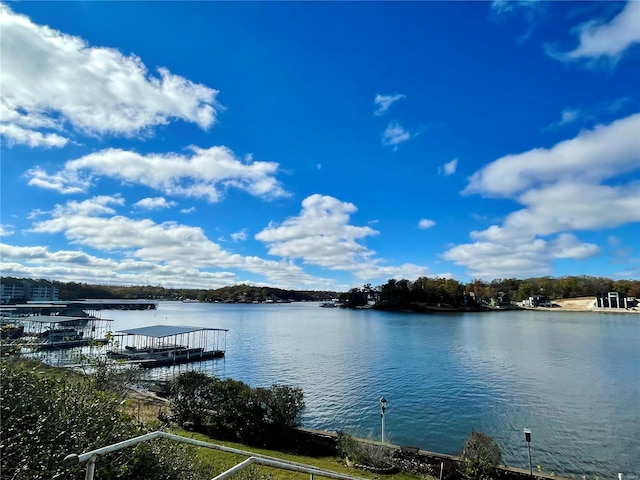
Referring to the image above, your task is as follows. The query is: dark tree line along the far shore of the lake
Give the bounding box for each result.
[5,275,640,307]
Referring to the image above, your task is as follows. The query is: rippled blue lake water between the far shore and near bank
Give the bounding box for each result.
[86,302,640,479]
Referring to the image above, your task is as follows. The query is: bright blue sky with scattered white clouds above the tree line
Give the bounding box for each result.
[0,1,640,291]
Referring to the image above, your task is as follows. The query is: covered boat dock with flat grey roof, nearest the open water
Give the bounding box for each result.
[107,325,228,368]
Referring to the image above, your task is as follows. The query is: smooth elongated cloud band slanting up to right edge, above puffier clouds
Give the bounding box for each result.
[463,114,640,197]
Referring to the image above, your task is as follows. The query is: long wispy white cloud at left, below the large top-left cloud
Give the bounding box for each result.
[26,147,288,202]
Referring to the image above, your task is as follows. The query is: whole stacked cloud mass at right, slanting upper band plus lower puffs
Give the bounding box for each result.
[443,114,640,279]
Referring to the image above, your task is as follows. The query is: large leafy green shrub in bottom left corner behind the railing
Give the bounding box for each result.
[0,360,207,480]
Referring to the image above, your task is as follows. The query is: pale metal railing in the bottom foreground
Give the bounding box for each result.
[62,431,365,480]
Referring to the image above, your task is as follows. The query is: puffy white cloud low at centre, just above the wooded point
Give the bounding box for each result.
[255,194,427,279]
